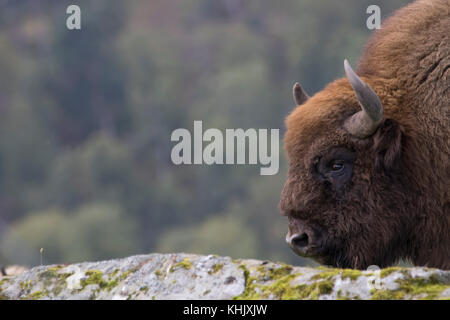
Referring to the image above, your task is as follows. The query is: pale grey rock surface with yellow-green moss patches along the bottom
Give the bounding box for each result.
[0,253,450,300]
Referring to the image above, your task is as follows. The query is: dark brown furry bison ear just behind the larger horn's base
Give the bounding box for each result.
[373,119,403,169]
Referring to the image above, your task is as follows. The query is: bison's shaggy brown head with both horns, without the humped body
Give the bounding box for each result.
[280,61,406,269]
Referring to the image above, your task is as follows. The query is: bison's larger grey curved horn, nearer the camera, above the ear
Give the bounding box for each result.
[344,59,383,138]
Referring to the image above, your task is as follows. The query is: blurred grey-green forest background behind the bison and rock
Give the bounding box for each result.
[0,0,408,265]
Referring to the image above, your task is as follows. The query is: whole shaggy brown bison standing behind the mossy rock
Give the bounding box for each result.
[280,0,450,269]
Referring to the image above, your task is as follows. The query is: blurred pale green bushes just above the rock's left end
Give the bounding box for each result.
[2,203,138,265]
